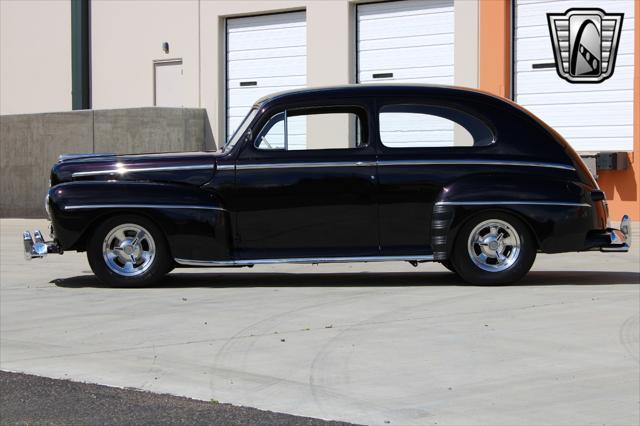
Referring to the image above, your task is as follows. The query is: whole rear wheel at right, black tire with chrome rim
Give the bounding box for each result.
[451,212,537,285]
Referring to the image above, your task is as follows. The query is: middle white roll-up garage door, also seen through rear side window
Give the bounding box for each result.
[357,0,455,147]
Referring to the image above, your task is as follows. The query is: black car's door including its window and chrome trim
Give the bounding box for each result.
[230,105,379,259]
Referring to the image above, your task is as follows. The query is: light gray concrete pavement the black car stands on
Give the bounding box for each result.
[0,219,640,425]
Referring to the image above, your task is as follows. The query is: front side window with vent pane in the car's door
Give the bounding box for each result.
[255,108,366,151]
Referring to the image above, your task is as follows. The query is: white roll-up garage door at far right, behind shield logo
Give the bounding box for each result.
[514,0,638,152]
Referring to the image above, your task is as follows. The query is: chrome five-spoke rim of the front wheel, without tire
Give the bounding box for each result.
[102,223,156,277]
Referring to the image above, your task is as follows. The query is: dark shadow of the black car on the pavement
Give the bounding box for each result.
[51,271,640,288]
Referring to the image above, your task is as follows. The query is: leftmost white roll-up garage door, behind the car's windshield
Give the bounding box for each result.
[227,12,307,139]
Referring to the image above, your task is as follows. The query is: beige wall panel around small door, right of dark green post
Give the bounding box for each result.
[90,0,200,109]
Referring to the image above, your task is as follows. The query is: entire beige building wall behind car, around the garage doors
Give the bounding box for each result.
[0,0,478,148]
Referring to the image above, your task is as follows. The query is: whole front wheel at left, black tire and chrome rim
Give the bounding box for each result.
[87,215,173,287]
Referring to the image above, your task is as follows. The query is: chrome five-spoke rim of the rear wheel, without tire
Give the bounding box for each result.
[467,219,520,272]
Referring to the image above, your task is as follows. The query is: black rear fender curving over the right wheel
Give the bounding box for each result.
[431,171,606,259]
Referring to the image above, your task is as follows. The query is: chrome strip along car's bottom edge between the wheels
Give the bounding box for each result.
[174,255,433,266]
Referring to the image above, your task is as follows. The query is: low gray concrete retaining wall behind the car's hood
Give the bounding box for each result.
[0,108,213,217]
